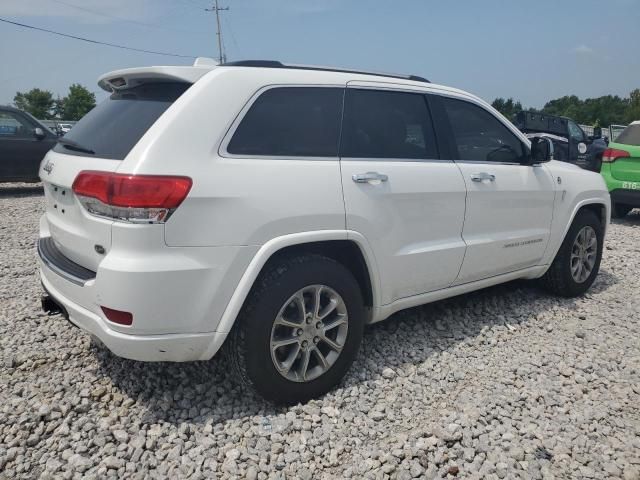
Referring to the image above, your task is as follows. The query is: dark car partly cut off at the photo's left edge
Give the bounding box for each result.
[0,107,58,182]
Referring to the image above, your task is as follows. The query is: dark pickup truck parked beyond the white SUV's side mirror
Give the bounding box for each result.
[515,111,607,172]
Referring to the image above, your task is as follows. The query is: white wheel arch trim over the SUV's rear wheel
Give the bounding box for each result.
[216,230,379,333]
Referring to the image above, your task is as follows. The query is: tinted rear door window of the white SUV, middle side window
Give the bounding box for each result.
[340,88,438,159]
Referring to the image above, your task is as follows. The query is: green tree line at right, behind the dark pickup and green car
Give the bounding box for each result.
[491,88,640,127]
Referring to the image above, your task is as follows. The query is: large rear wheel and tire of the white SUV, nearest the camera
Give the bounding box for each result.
[226,254,365,404]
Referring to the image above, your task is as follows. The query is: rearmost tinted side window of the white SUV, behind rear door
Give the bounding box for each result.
[227,87,344,157]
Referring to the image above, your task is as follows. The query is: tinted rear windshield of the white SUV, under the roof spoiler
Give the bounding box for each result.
[53,83,190,160]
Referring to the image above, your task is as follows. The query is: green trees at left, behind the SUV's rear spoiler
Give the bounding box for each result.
[13,83,96,120]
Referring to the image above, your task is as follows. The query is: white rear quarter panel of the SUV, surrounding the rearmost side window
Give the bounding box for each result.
[119,69,345,247]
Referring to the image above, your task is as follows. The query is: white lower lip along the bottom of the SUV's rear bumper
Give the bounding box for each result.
[40,272,226,362]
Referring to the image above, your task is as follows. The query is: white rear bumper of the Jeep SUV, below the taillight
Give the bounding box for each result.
[38,216,252,362]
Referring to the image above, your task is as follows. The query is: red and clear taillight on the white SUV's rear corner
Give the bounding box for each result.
[72,171,192,223]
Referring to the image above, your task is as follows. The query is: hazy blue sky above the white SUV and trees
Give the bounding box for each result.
[0,0,640,108]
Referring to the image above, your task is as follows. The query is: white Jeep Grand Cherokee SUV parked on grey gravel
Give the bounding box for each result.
[38,61,610,403]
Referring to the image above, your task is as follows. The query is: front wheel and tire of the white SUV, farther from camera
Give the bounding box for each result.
[540,210,604,297]
